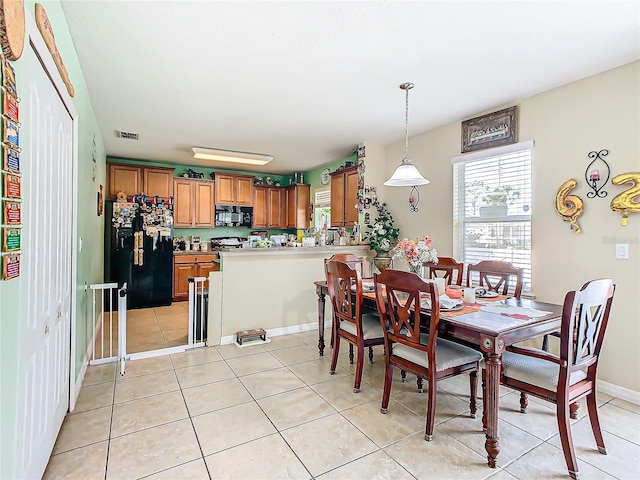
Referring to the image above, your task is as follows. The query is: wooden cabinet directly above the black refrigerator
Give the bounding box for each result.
[106,163,174,200]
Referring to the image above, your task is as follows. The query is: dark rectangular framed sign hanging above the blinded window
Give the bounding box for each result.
[462,106,518,153]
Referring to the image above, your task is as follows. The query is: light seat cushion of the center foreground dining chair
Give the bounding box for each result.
[392,334,482,372]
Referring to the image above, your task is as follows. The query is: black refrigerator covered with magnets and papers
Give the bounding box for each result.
[104,199,173,309]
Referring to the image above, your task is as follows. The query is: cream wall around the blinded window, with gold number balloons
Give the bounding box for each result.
[378,62,640,392]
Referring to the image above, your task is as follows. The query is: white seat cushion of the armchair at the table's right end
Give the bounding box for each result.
[502,352,587,392]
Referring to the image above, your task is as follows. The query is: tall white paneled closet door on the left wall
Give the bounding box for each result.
[16,39,73,478]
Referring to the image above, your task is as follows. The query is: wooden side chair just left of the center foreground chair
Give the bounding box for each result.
[325,260,384,393]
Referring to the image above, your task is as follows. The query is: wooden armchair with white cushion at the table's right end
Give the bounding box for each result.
[490,279,615,478]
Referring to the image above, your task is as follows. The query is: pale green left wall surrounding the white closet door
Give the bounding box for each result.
[0,0,105,478]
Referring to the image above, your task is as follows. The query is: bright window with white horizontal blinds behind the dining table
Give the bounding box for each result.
[452,141,533,293]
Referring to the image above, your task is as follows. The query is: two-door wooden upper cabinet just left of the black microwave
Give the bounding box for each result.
[173,178,215,228]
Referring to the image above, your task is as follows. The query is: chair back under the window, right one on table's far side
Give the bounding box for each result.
[466,260,523,298]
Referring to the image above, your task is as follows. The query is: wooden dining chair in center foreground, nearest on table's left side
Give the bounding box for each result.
[374,270,482,441]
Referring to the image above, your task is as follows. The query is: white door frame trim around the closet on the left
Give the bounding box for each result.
[25,15,80,411]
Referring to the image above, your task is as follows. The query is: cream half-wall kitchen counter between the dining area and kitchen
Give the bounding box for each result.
[207,245,373,345]
